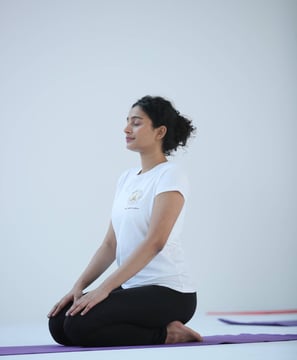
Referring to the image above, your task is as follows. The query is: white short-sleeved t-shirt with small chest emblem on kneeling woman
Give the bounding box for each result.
[112,162,195,292]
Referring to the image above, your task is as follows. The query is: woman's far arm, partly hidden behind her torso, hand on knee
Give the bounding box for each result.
[48,224,116,317]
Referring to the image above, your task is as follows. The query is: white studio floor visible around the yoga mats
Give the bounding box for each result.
[0,314,297,360]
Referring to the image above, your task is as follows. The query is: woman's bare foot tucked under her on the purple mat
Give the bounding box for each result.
[165,321,203,344]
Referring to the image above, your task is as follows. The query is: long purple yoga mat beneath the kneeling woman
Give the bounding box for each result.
[0,334,297,356]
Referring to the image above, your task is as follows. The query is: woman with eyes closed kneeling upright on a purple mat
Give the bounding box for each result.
[48,96,202,346]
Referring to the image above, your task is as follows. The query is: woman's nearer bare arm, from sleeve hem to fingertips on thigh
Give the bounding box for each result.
[68,191,184,315]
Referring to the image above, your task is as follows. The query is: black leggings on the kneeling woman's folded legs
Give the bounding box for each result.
[49,285,196,346]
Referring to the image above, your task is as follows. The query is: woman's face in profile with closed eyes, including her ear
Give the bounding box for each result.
[124,106,166,153]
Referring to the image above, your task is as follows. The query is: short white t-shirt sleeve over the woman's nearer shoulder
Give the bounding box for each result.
[155,166,189,200]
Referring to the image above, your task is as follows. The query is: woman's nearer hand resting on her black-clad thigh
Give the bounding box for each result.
[66,286,109,316]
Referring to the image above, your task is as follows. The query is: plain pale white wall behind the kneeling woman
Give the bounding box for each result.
[0,0,297,323]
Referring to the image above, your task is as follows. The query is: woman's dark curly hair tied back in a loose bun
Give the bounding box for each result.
[132,95,196,155]
